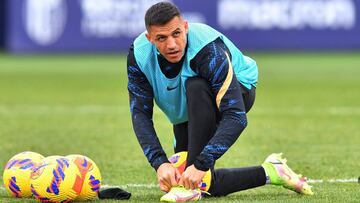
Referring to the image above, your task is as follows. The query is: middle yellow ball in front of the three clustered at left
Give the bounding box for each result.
[30,156,80,202]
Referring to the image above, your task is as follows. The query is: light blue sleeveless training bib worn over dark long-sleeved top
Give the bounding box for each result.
[134,23,258,124]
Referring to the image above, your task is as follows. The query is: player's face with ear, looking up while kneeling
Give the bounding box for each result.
[146,16,188,63]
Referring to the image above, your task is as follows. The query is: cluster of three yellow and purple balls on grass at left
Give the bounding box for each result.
[3,152,101,202]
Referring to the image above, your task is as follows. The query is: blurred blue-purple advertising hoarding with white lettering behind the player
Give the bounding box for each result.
[6,0,360,53]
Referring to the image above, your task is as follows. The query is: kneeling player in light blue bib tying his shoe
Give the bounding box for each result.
[127,2,312,201]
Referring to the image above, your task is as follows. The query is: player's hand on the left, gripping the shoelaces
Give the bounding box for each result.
[156,163,181,192]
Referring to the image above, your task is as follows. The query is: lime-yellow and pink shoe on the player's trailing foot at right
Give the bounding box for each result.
[262,153,314,195]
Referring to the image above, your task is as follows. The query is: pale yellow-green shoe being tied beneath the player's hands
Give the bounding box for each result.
[160,186,202,202]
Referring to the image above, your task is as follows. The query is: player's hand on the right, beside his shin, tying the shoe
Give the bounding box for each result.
[179,164,206,190]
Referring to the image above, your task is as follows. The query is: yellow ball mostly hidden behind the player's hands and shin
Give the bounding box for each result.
[169,151,211,191]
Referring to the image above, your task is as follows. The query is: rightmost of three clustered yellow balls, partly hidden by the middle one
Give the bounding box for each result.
[66,154,101,201]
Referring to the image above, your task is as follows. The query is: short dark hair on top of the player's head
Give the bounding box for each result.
[145,1,181,30]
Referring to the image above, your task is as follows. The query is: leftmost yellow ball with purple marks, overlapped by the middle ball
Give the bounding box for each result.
[3,151,44,198]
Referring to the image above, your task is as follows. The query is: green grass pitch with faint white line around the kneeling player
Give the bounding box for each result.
[0,53,360,202]
